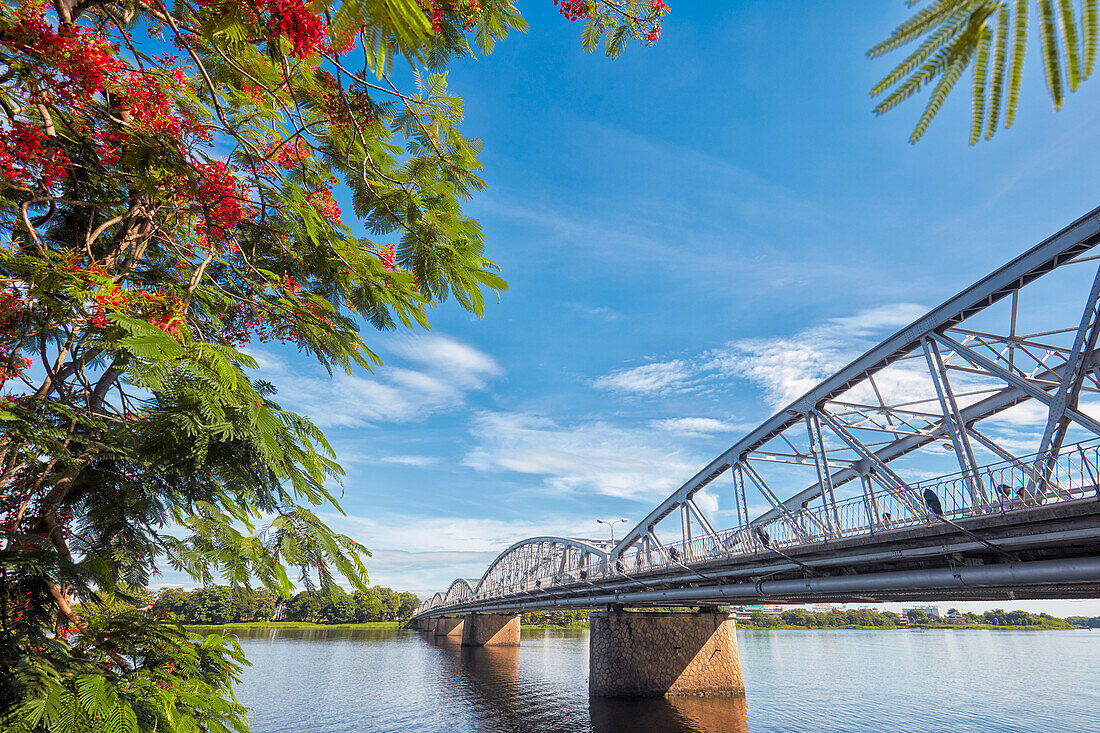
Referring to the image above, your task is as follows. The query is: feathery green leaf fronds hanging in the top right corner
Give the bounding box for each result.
[867,0,1100,145]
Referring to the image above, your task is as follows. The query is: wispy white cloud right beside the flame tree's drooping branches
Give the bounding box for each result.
[251,335,502,428]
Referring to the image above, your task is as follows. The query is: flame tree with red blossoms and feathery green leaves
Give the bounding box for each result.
[0,0,667,731]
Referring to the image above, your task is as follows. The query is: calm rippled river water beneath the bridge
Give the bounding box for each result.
[225,630,1100,733]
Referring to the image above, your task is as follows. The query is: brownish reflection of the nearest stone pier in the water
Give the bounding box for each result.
[589,694,749,733]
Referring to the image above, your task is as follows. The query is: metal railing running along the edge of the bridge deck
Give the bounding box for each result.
[421,441,1100,610]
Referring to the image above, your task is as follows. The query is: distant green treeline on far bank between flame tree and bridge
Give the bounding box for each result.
[153,586,420,624]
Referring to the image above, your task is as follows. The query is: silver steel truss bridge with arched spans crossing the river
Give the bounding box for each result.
[416,209,1100,617]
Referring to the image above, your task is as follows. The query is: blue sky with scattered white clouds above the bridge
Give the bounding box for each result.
[227,0,1100,613]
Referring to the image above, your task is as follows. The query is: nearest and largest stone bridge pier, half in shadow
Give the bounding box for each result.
[589,611,745,698]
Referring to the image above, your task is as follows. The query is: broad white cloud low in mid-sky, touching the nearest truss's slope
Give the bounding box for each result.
[464,413,703,500]
